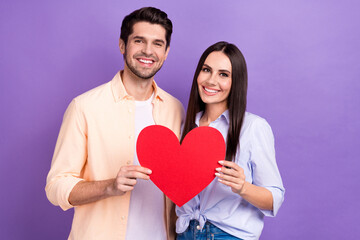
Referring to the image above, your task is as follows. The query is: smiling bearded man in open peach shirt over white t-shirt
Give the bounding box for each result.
[45,7,184,240]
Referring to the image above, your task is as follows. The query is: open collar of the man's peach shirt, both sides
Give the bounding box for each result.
[111,71,164,102]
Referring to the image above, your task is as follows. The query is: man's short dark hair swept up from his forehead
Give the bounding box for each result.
[120,7,172,48]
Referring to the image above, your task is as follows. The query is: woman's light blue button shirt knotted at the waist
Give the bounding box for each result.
[176,110,285,240]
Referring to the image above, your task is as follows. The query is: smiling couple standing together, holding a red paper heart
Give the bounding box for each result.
[45,7,284,240]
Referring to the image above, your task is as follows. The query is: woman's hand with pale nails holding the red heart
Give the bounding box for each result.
[215,161,246,195]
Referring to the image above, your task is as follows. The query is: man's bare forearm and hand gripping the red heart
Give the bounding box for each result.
[69,165,151,206]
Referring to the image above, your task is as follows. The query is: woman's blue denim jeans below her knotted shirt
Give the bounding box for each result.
[176,220,242,240]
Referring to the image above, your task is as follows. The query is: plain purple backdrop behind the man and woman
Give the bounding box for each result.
[0,0,360,240]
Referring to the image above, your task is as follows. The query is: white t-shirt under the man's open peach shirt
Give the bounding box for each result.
[126,94,166,240]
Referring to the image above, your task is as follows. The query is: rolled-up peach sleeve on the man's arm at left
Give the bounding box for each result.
[45,99,87,210]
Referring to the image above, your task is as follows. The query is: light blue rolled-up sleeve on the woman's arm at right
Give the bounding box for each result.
[251,118,285,217]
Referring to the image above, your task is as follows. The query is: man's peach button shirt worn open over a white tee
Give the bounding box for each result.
[45,72,184,240]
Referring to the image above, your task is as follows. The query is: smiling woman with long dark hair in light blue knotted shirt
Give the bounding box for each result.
[176,42,285,240]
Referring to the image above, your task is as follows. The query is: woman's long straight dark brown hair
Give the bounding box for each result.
[181,42,248,161]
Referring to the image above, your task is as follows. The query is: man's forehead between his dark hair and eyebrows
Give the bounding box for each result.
[129,22,166,42]
